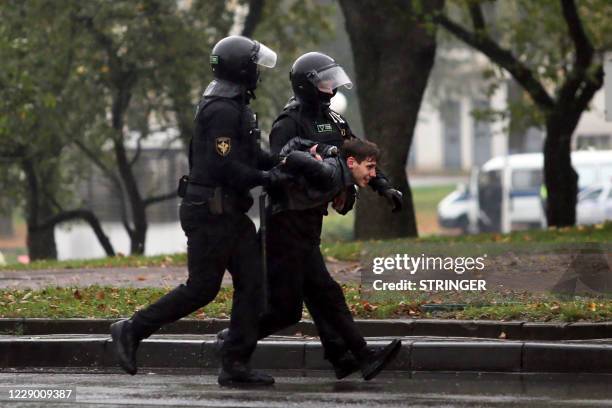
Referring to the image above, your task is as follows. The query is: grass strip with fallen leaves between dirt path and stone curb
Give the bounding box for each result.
[0,285,612,322]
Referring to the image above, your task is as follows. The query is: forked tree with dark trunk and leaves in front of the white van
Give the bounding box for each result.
[435,0,612,227]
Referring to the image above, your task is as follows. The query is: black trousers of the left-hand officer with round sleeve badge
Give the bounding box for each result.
[133,201,263,363]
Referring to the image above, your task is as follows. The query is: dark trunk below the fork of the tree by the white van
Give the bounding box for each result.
[544,113,580,227]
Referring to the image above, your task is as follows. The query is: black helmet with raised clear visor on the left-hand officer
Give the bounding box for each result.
[210,35,276,90]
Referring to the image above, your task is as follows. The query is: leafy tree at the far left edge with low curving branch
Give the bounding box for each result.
[0,1,113,259]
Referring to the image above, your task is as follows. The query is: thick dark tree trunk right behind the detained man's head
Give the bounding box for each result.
[340,0,444,239]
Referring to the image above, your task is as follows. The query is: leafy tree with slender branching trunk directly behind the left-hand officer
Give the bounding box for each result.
[76,0,332,253]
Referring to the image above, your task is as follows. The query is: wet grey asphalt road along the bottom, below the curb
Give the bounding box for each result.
[0,371,612,408]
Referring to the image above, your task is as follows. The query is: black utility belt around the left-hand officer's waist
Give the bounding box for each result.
[177,176,253,215]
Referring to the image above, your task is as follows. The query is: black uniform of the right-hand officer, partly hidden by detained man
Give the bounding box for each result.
[259,100,389,362]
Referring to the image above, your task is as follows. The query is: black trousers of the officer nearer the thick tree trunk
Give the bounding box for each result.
[259,212,366,362]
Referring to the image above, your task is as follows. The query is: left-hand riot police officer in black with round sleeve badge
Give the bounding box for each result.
[111,36,280,385]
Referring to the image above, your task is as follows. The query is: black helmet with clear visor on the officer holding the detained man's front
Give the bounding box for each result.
[289,52,353,107]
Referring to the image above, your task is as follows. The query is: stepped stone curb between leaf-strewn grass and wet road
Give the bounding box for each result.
[0,319,612,373]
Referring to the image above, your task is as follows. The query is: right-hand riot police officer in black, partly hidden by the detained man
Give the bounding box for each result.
[259,52,402,379]
